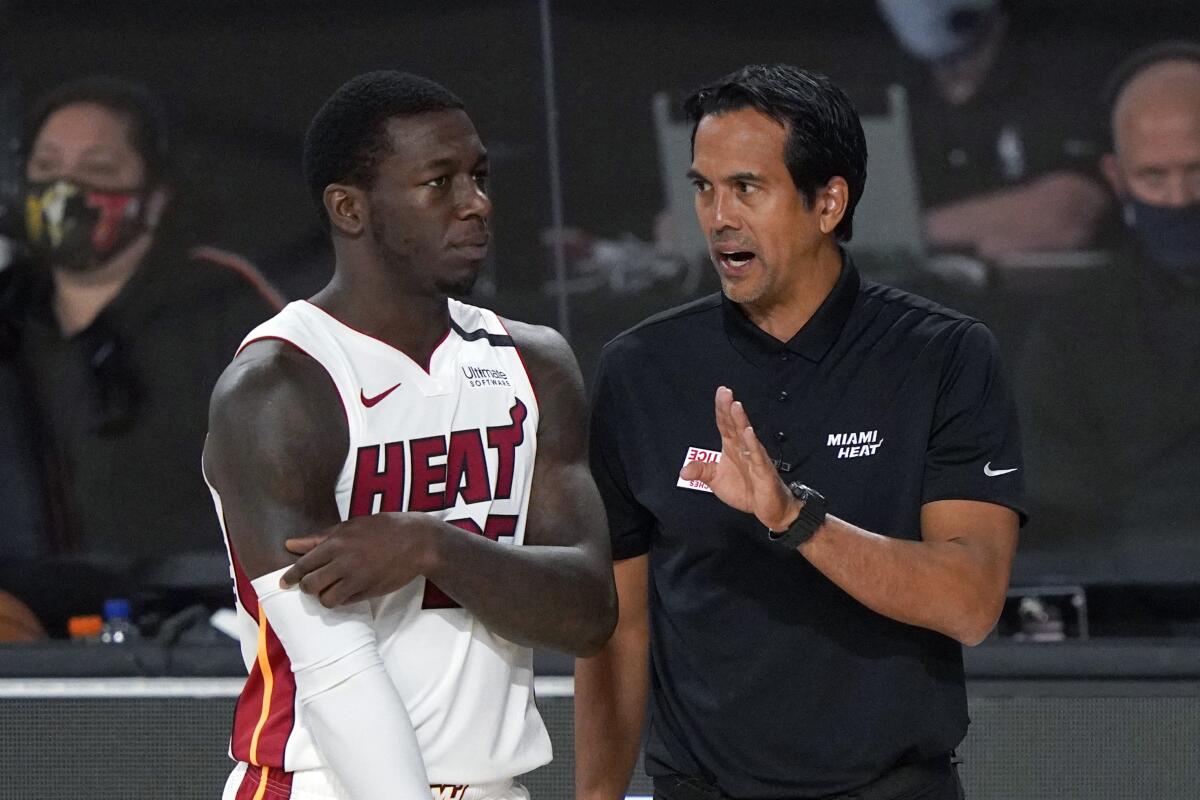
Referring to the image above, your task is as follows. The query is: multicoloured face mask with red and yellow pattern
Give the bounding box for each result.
[25,179,146,272]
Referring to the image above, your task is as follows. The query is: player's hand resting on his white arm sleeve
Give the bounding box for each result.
[280,513,433,608]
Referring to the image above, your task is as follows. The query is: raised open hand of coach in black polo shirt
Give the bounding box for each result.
[679,386,799,530]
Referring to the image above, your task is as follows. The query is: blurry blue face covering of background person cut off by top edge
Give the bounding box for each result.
[878,0,996,64]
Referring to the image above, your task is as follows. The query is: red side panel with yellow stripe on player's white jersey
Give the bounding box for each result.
[229,542,296,770]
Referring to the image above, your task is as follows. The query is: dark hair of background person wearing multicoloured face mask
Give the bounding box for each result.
[22,76,170,185]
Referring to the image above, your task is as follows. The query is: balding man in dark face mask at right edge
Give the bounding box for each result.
[1020,42,1200,623]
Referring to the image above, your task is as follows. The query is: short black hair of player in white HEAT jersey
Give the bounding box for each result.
[304,71,463,228]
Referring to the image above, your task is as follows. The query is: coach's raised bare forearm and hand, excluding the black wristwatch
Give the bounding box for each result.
[680,386,1019,645]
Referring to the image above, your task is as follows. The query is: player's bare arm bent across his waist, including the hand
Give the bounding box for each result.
[283,320,617,655]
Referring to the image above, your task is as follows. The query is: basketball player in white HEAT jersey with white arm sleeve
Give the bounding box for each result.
[204,72,616,800]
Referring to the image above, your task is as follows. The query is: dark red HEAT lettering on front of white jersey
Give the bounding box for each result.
[349,398,529,517]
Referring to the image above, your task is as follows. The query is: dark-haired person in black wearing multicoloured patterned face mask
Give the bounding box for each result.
[0,78,281,627]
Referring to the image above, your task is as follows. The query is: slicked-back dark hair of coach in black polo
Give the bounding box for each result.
[684,64,866,241]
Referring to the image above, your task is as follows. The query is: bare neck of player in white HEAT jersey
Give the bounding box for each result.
[308,270,450,363]
